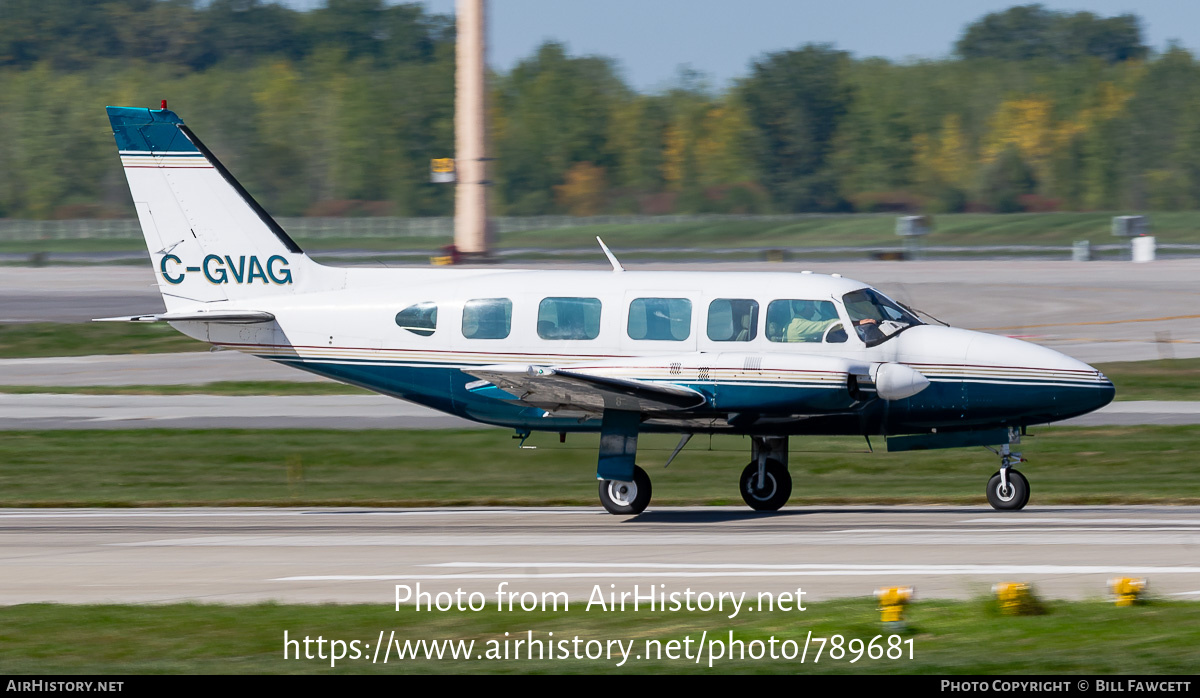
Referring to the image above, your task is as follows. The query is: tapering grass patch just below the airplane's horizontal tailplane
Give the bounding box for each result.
[0,323,209,359]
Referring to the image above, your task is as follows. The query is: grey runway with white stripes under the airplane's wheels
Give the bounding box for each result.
[0,506,1200,606]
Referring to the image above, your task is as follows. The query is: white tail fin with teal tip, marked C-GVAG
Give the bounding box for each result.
[107,102,343,309]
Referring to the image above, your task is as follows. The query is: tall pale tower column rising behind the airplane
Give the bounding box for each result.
[454,0,491,257]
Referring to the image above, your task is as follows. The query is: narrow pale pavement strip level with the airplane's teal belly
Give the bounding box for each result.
[0,393,1200,431]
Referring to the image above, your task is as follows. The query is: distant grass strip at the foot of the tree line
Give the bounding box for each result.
[0,211,1200,260]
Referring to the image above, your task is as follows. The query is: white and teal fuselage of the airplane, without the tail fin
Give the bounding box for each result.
[176,267,1111,432]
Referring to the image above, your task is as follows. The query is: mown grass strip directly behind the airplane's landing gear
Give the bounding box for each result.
[0,426,1200,506]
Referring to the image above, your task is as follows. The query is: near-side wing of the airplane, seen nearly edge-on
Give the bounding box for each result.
[463,365,708,414]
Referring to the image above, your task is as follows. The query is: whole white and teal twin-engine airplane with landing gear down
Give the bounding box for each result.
[103,102,1115,515]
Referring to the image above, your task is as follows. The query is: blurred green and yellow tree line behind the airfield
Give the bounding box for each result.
[0,0,1200,218]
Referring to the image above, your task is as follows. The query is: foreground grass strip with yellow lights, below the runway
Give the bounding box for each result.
[0,599,1200,686]
